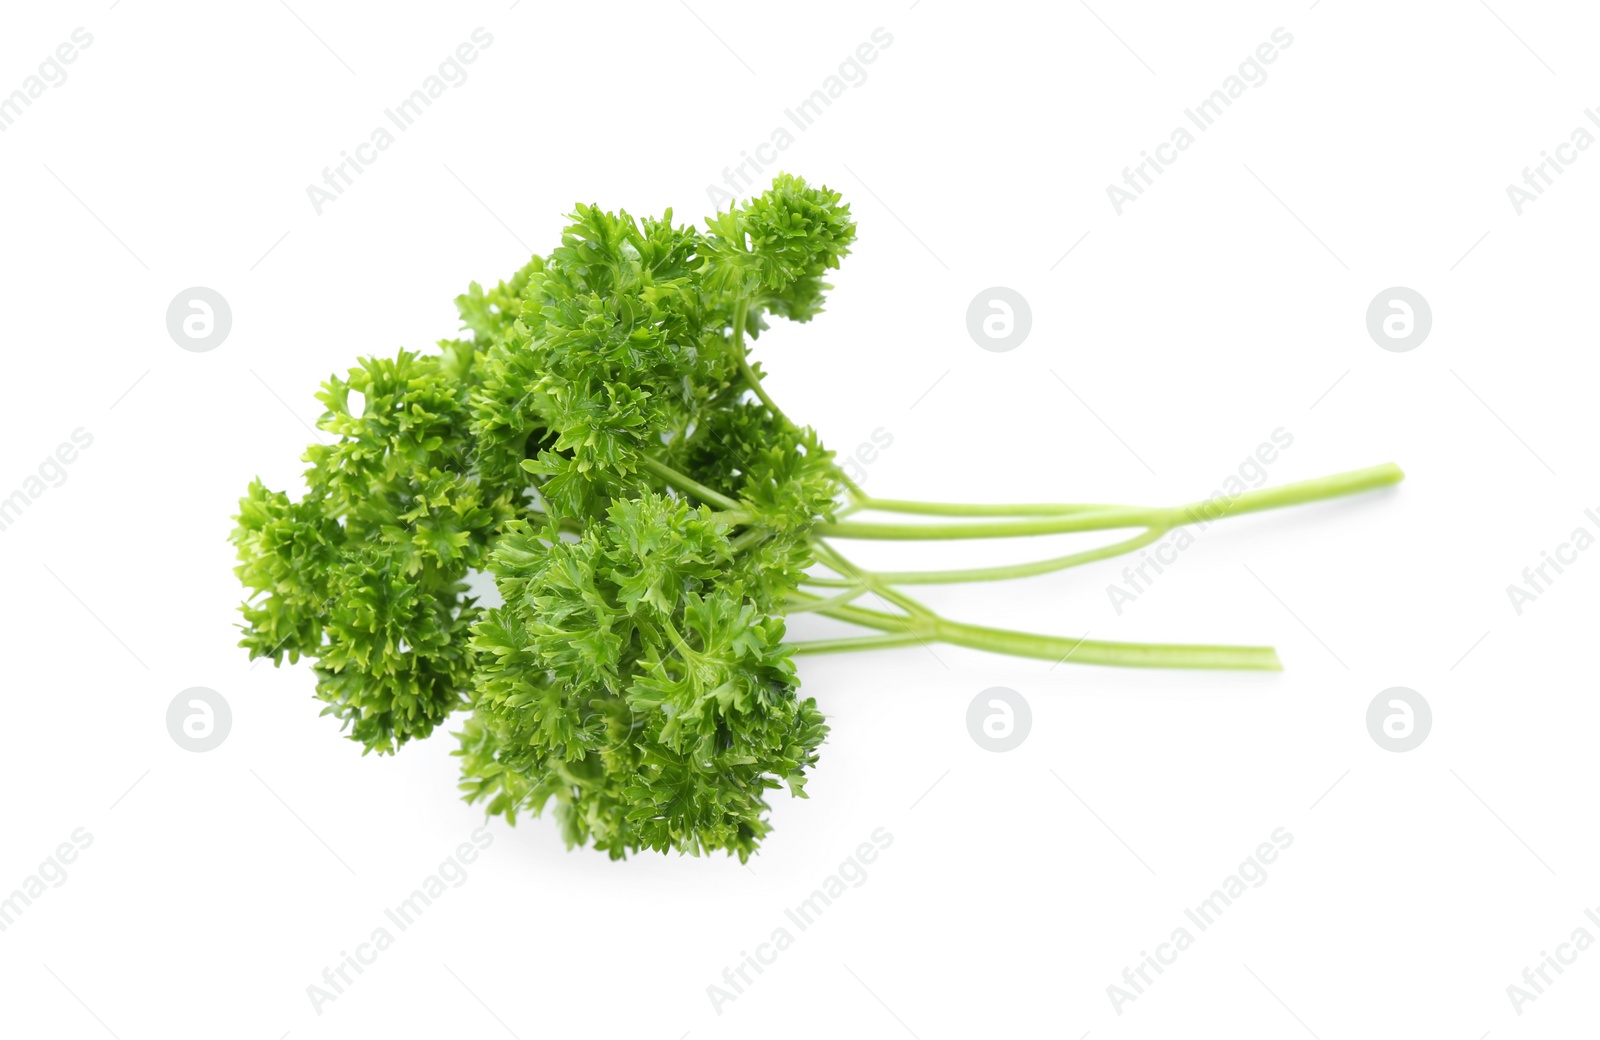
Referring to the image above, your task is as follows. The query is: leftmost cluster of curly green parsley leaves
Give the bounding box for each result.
[234,342,522,752]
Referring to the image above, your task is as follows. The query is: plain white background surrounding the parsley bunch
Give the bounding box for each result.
[0,0,1600,1040]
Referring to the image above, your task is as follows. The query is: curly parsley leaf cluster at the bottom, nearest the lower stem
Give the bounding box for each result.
[462,493,827,856]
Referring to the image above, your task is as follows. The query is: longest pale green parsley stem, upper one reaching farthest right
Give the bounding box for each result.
[813,462,1405,541]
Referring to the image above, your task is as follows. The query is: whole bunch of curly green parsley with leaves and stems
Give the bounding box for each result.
[234,174,1402,859]
